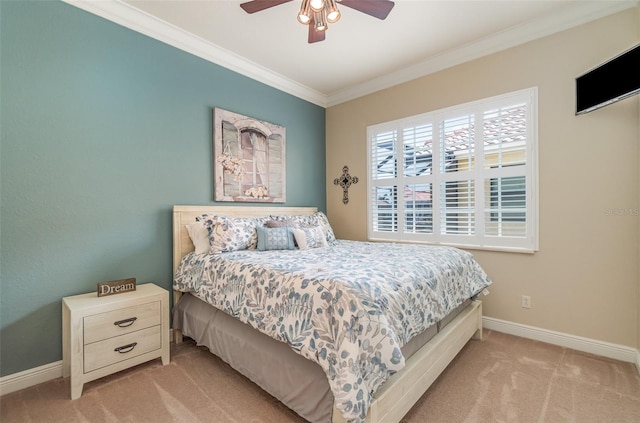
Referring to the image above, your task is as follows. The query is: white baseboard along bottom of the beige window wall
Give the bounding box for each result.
[482,317,640,366]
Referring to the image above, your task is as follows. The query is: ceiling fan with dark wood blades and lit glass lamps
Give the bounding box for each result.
[240,0,395,44]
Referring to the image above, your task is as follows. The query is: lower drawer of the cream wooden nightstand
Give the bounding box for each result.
[84,325,162,373]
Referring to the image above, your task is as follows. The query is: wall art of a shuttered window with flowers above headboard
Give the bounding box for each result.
[213,108,286,203]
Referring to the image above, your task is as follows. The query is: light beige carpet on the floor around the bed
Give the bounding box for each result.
[0,331,640,423]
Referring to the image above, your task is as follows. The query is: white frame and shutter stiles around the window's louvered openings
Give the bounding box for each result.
[367,87,539,253]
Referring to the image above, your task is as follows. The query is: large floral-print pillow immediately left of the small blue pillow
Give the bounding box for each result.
[196,215,266,254]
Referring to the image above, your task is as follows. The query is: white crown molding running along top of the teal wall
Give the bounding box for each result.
[62,0,327,107]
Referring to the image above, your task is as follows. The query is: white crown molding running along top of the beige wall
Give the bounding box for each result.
[327,0,640,107]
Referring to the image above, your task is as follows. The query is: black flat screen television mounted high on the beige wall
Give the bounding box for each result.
[576,44,640,115]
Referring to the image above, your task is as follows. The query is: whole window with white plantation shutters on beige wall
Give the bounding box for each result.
[367,88,538,252]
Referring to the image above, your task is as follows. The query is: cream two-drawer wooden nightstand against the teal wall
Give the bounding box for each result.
[62,283,169,399]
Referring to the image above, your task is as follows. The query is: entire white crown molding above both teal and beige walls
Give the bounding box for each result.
[62,0,640,108]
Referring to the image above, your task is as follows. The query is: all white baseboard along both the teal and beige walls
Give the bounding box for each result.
[0,324,640,396]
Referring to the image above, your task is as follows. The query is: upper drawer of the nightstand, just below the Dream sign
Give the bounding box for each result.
[84,301,160,345]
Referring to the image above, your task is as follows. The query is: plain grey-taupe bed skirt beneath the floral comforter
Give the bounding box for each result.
[173,294,469,423]
